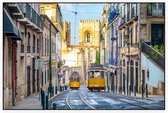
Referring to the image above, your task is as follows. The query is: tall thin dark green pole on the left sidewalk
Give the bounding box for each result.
[49,23,53,98]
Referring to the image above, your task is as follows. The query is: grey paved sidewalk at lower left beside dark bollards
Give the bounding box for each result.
[9,94,42,110]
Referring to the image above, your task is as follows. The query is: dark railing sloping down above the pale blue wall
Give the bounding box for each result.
[141,41,165,69]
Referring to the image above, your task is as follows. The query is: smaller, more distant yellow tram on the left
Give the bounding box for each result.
[69,71,80,89]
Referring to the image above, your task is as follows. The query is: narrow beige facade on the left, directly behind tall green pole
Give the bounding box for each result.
[41,14,58,94]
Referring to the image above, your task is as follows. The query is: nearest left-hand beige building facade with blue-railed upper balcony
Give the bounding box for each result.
[4,3,43,108]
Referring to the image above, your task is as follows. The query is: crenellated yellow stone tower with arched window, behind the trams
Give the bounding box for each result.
[79,20,101,80]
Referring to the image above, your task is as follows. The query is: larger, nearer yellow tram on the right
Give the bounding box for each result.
[87,64,106,91]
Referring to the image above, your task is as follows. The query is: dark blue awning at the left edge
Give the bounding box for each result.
[3,9,22,40]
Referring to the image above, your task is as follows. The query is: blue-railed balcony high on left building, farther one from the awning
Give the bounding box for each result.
[18,3,43,32]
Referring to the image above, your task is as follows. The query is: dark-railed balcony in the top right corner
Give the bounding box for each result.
[147,3,165,17]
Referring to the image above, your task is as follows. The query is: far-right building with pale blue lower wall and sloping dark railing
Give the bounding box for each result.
[139,3,165,96]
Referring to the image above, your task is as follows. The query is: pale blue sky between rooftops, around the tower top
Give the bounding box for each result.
[59,3,104,45]
